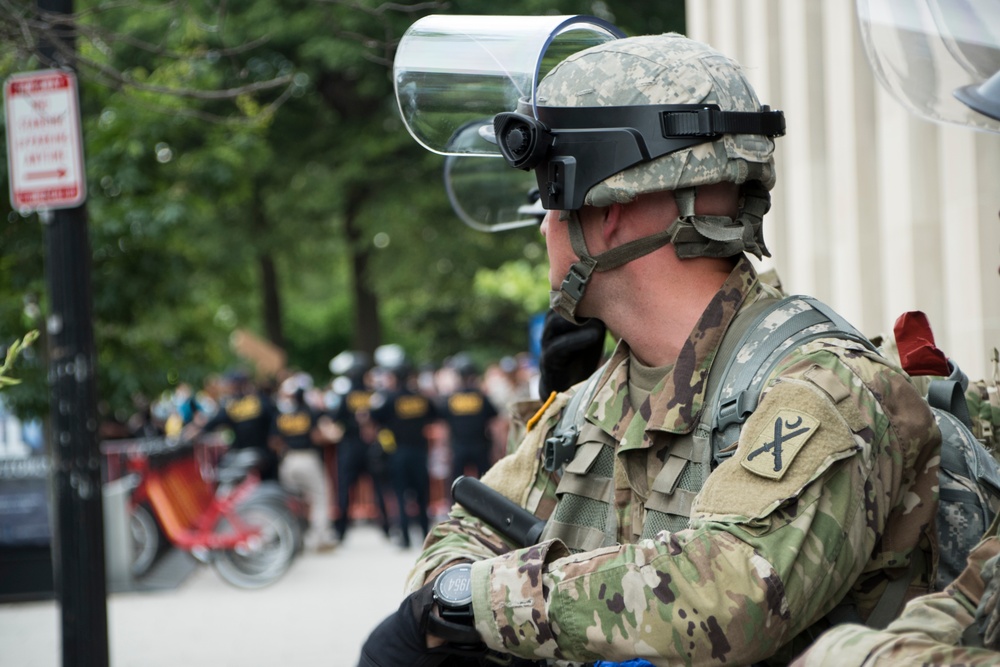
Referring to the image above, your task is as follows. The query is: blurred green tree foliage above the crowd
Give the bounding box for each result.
[0,0,683,420]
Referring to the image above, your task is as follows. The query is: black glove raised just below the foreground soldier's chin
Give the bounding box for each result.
[538,309,606,400]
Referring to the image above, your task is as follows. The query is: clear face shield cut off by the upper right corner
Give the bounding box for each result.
[857,0,1000,132]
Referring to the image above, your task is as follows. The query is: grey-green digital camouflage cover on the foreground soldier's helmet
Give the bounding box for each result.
[537,33,775,206]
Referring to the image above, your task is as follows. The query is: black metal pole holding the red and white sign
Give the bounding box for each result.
[37,0,109,667]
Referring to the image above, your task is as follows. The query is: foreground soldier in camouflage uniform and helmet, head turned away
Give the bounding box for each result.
[362,34,940,665]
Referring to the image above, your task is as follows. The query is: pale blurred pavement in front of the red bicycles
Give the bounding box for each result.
[0,525,420,667]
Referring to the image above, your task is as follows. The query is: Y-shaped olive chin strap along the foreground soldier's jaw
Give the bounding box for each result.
[549,211,671,324]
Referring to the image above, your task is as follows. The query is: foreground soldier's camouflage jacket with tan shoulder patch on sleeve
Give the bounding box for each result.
[409,260,940,665]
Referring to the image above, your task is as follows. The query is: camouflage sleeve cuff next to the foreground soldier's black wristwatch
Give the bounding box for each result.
[472,540,568,658]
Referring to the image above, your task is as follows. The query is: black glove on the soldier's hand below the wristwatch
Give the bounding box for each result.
[358,581,486,667]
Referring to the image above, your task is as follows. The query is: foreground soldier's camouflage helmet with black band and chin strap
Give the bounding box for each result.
[494,33,784,320]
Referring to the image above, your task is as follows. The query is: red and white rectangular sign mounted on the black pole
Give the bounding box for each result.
[3,70,87,211]
